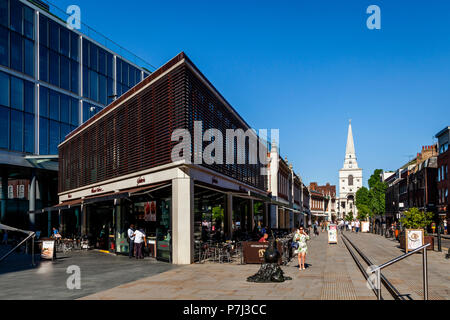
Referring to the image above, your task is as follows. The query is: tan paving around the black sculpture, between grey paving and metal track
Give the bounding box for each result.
[84,233,375,300]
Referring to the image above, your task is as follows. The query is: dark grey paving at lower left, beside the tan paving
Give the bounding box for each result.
[0,251,177,300]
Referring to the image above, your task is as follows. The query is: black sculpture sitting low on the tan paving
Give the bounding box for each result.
[247,235,292,282]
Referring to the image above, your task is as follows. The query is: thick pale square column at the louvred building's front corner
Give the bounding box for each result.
[172,178,194,264]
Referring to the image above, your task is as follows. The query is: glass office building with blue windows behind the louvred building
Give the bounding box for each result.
[0,0,150,234]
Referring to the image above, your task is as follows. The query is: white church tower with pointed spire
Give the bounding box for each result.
[339,120,363,218]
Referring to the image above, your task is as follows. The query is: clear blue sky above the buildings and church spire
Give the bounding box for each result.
[52,0,450,189]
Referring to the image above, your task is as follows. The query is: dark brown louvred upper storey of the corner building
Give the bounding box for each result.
[59,53,266,193]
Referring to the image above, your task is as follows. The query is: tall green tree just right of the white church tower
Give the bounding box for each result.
[355,169,387,218]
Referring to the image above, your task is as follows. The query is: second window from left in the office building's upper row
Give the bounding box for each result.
[39,15,79,94]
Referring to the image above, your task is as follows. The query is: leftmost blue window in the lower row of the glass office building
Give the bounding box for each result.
[0,72,34,153]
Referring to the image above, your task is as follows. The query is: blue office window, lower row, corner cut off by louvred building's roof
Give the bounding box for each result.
[39,86,79,155]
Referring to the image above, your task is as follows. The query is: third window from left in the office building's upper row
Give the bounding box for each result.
[83,39,113,105]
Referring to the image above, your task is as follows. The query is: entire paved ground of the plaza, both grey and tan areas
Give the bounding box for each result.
[0,232,450,300]
